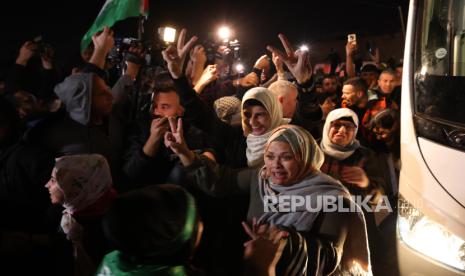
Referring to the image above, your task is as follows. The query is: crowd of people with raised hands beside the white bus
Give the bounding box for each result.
[0,27,402,275]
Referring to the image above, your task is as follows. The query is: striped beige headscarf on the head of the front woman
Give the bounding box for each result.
[262,125,325,181]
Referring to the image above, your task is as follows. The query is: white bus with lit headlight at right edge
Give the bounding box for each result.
[397,0,465,276]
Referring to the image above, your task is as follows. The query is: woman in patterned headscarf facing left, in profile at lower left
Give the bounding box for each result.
[45,154,116,275]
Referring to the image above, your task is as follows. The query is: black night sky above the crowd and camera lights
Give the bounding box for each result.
[0,0,408,68]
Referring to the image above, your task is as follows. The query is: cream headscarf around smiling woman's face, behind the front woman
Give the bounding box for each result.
[241,87,289,167]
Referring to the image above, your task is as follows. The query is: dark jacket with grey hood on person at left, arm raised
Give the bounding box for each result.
[31,73,132,183]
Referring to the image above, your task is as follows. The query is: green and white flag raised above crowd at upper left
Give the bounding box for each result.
[81,0,148,52]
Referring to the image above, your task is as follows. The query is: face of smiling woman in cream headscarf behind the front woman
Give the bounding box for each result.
[242,105,271,136]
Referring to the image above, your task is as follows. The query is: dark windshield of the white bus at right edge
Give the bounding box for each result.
[414,0,465,128]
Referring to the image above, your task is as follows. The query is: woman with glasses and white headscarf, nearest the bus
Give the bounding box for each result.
[320,108,390,275]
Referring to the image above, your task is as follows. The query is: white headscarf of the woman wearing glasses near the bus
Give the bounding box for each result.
[320,108,360,160]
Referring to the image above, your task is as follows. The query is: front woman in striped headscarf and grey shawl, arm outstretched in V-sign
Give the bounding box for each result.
[165,123,371,275]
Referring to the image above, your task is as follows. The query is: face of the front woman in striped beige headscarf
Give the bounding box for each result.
[265,141,300,185]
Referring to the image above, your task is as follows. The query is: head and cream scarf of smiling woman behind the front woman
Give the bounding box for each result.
[241,87,289,168]
